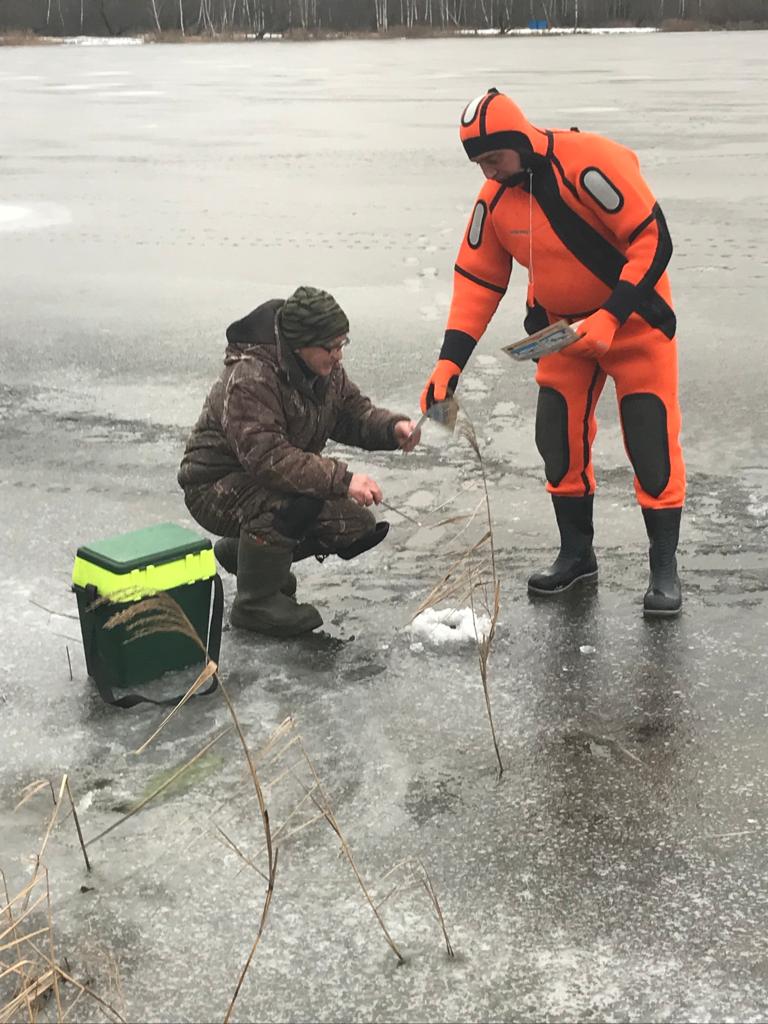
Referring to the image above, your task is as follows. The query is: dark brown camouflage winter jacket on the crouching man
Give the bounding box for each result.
[178,299,408,498]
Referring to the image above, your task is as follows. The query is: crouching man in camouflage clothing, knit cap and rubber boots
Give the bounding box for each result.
[178,287,420,637]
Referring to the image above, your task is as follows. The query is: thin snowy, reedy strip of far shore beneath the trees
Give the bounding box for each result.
[0,20,768,46]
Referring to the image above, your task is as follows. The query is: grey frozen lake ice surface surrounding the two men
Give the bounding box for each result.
[0,33,768,1021]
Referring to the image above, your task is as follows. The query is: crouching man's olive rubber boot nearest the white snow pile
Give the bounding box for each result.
[229,534,323,637]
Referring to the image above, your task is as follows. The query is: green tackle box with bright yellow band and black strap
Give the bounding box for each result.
[72,522,222,707]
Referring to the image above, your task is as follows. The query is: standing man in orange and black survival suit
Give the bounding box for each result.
[428,89,685,615]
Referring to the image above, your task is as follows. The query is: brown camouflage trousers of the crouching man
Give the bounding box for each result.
[184,473,376,553]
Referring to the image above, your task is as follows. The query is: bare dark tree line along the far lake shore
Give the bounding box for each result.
[0,0,768,37]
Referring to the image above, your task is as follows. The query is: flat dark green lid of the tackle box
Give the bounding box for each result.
[77,522,211,573]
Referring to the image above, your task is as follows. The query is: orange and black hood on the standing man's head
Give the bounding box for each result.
[460,89,548,167]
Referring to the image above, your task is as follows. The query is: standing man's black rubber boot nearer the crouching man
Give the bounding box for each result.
[528,495,597,597]
